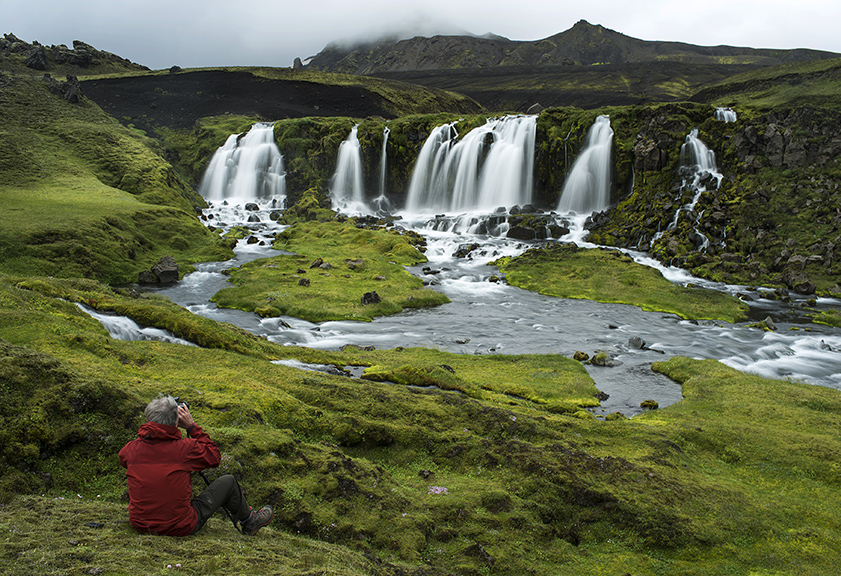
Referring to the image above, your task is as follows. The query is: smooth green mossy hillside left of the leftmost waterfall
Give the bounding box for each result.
[0,78,231,282]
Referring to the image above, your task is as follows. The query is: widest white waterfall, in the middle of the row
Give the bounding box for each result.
[406,116,537,213]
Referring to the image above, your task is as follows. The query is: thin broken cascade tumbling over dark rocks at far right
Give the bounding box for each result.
[653,128,724,250]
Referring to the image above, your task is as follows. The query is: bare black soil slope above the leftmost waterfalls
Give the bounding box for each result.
[82,70,393,132]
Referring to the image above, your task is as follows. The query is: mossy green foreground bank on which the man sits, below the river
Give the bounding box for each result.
[0,279,841,575]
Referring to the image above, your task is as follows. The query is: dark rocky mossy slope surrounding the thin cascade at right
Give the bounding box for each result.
[589,103,841,294]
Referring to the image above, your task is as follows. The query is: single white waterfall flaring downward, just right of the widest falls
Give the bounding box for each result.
[558,116,613,214]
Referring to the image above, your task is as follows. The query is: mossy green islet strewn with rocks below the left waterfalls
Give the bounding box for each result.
[211,221,449,322]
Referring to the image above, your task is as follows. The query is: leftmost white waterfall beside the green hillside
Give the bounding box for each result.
[199,123,286,200]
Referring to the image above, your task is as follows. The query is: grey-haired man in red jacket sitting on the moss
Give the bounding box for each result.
[120,395,272,536]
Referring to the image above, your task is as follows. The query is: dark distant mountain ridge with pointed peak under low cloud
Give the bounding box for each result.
[305,20,838,75]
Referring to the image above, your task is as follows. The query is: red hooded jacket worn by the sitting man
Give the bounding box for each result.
[120,422,221,536]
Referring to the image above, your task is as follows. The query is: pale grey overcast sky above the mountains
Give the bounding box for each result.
[6,0,841,69]
